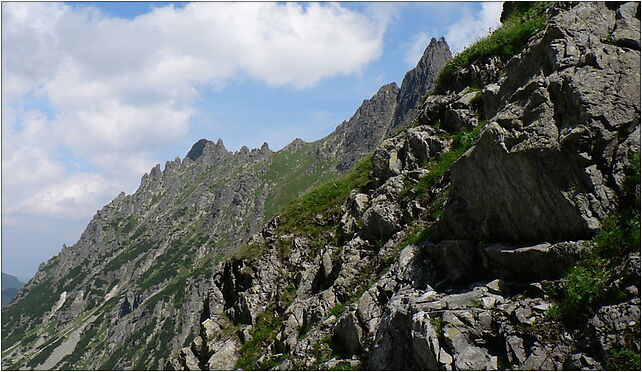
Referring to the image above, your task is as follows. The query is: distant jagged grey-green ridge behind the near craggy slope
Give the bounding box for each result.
[2,32,451,369]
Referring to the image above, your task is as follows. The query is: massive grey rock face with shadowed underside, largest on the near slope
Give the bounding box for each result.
[441,3,640,242]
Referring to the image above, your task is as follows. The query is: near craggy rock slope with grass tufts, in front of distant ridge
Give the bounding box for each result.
[166,3,640,370]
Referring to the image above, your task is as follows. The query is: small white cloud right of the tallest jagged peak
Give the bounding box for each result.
[446,2,503,52]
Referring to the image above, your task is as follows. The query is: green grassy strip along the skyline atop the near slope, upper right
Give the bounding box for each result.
[435,2,553,93]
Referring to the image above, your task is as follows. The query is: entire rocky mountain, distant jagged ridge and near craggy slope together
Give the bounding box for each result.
[2,2,641,370]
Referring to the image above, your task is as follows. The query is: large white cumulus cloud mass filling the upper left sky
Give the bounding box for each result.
[2,3,387,221]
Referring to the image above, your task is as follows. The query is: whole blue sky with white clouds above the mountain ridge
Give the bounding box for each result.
[2,2,501,278]
